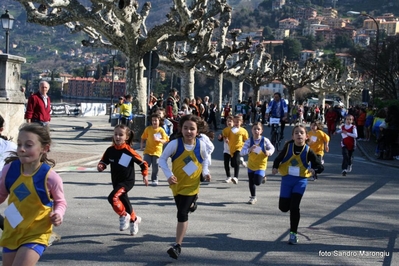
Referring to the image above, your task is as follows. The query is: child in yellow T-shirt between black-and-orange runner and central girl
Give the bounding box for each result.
[140,114,169,186]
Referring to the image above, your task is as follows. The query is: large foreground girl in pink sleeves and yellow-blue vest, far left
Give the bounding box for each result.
[0,123,67,265]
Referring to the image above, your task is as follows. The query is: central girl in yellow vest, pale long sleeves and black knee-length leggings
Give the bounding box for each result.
[159,115,211,259]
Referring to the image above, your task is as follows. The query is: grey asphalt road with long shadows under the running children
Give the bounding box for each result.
[0,117,399,266]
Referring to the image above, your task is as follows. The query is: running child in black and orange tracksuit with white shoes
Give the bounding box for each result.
[97,124,148,235]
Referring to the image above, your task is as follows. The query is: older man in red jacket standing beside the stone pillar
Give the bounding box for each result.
[25,81,51,126]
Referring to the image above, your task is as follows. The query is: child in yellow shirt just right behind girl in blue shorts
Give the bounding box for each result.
[308,121,330,181]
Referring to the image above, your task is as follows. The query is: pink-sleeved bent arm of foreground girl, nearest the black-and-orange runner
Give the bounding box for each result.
[47,170,67,226]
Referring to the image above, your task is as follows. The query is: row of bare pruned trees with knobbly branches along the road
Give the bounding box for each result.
[13,0,396,112]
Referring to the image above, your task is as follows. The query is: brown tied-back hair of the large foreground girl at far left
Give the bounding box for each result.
[5,123,55,167]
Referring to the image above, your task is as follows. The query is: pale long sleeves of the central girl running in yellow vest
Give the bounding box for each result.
[159,139,209,179]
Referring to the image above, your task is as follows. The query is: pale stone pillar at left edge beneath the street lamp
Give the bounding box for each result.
[0,54,26,142]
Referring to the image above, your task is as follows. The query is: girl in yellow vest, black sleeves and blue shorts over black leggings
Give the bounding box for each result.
[272,125,324,245]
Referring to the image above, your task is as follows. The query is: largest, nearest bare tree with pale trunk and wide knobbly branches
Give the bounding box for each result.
[16,0,231,112]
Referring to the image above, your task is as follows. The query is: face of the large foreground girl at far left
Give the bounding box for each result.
[17,131,48,164]
